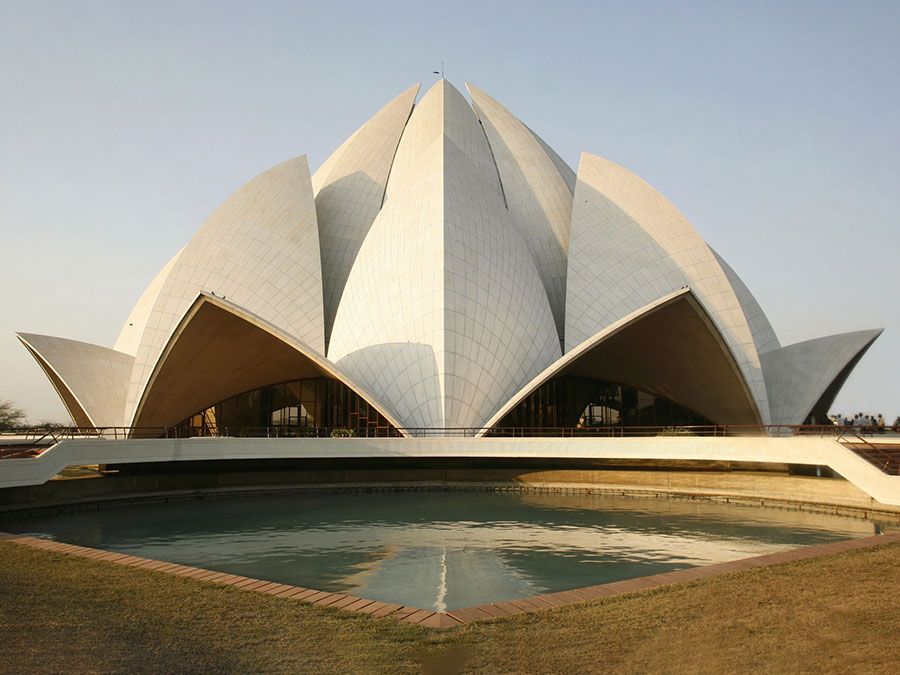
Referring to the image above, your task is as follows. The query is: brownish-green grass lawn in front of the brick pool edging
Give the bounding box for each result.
[0,541,900,673]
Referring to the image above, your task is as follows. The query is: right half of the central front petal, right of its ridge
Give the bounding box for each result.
[444,140,560,427]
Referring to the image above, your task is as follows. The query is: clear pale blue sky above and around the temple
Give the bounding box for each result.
[0,0,900,421]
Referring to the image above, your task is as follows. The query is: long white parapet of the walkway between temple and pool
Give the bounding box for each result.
[0,436,900,506]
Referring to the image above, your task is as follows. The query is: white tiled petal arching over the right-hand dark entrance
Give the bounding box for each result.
[565,152,769,423]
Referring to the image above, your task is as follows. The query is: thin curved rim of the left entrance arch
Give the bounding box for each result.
[132,292,408,436]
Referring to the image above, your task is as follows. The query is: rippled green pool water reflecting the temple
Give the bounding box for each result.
[0,492,874,610]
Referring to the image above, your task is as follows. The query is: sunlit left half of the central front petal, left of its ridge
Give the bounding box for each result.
[328,140,444,428]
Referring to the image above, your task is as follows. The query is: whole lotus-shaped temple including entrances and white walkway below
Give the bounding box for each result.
[7,79,900,505]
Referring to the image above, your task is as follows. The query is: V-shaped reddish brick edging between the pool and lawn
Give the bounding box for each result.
[0,532,900,628]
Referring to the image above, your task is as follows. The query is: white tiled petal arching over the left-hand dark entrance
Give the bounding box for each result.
[123,155,325,428]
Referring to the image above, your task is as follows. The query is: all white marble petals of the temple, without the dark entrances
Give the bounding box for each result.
[20,80,879,429]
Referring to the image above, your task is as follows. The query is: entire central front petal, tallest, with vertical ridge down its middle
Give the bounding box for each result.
[329,81,560,428]
